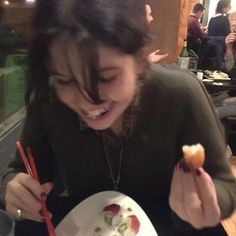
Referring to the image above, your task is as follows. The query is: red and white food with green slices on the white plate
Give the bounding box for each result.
[93,203,140,236]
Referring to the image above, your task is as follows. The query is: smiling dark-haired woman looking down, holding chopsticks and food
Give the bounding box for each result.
[1,0,236,236]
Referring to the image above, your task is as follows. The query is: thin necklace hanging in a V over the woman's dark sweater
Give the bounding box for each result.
[101,134,124,190]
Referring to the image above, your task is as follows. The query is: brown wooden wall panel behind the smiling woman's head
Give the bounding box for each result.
[150,0,190,63]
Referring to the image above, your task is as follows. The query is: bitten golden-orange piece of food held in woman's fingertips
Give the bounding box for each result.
[182,143,205,169]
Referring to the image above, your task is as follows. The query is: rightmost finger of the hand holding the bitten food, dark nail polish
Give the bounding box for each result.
[195,168,221,226]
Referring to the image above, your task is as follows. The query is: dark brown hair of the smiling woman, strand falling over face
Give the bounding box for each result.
[26,0,149,109]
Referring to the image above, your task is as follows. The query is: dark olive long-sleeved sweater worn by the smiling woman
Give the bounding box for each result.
[1,65,236,236]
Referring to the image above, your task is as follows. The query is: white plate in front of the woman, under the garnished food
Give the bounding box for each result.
[56,191,158,236]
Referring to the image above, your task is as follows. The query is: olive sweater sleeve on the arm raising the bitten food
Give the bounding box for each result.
[171,71,236,230]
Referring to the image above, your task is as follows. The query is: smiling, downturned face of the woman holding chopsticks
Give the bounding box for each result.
[50,37,140,130]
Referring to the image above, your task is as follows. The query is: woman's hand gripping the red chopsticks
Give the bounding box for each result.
[5,173,53,222]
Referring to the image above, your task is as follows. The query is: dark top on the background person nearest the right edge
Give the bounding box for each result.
[208,14,230,36]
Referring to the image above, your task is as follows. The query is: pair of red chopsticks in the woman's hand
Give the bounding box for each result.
[16,141,56,236]
